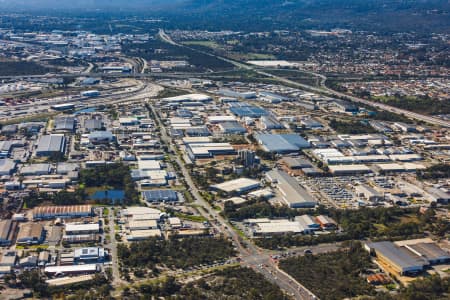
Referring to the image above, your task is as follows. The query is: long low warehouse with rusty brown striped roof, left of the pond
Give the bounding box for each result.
[33,205,93,220]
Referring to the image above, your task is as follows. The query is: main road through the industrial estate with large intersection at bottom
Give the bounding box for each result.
[149,104,316,299]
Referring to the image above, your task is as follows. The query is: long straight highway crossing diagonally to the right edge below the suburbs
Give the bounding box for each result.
[159,29,450,127]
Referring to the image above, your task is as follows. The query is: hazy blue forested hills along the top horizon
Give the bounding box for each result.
[0,0,450,33]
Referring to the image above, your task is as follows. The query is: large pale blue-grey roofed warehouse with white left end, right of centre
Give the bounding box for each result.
[255,134,310,153]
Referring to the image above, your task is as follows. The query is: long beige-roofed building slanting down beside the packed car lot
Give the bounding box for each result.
[266,169,317,208]
